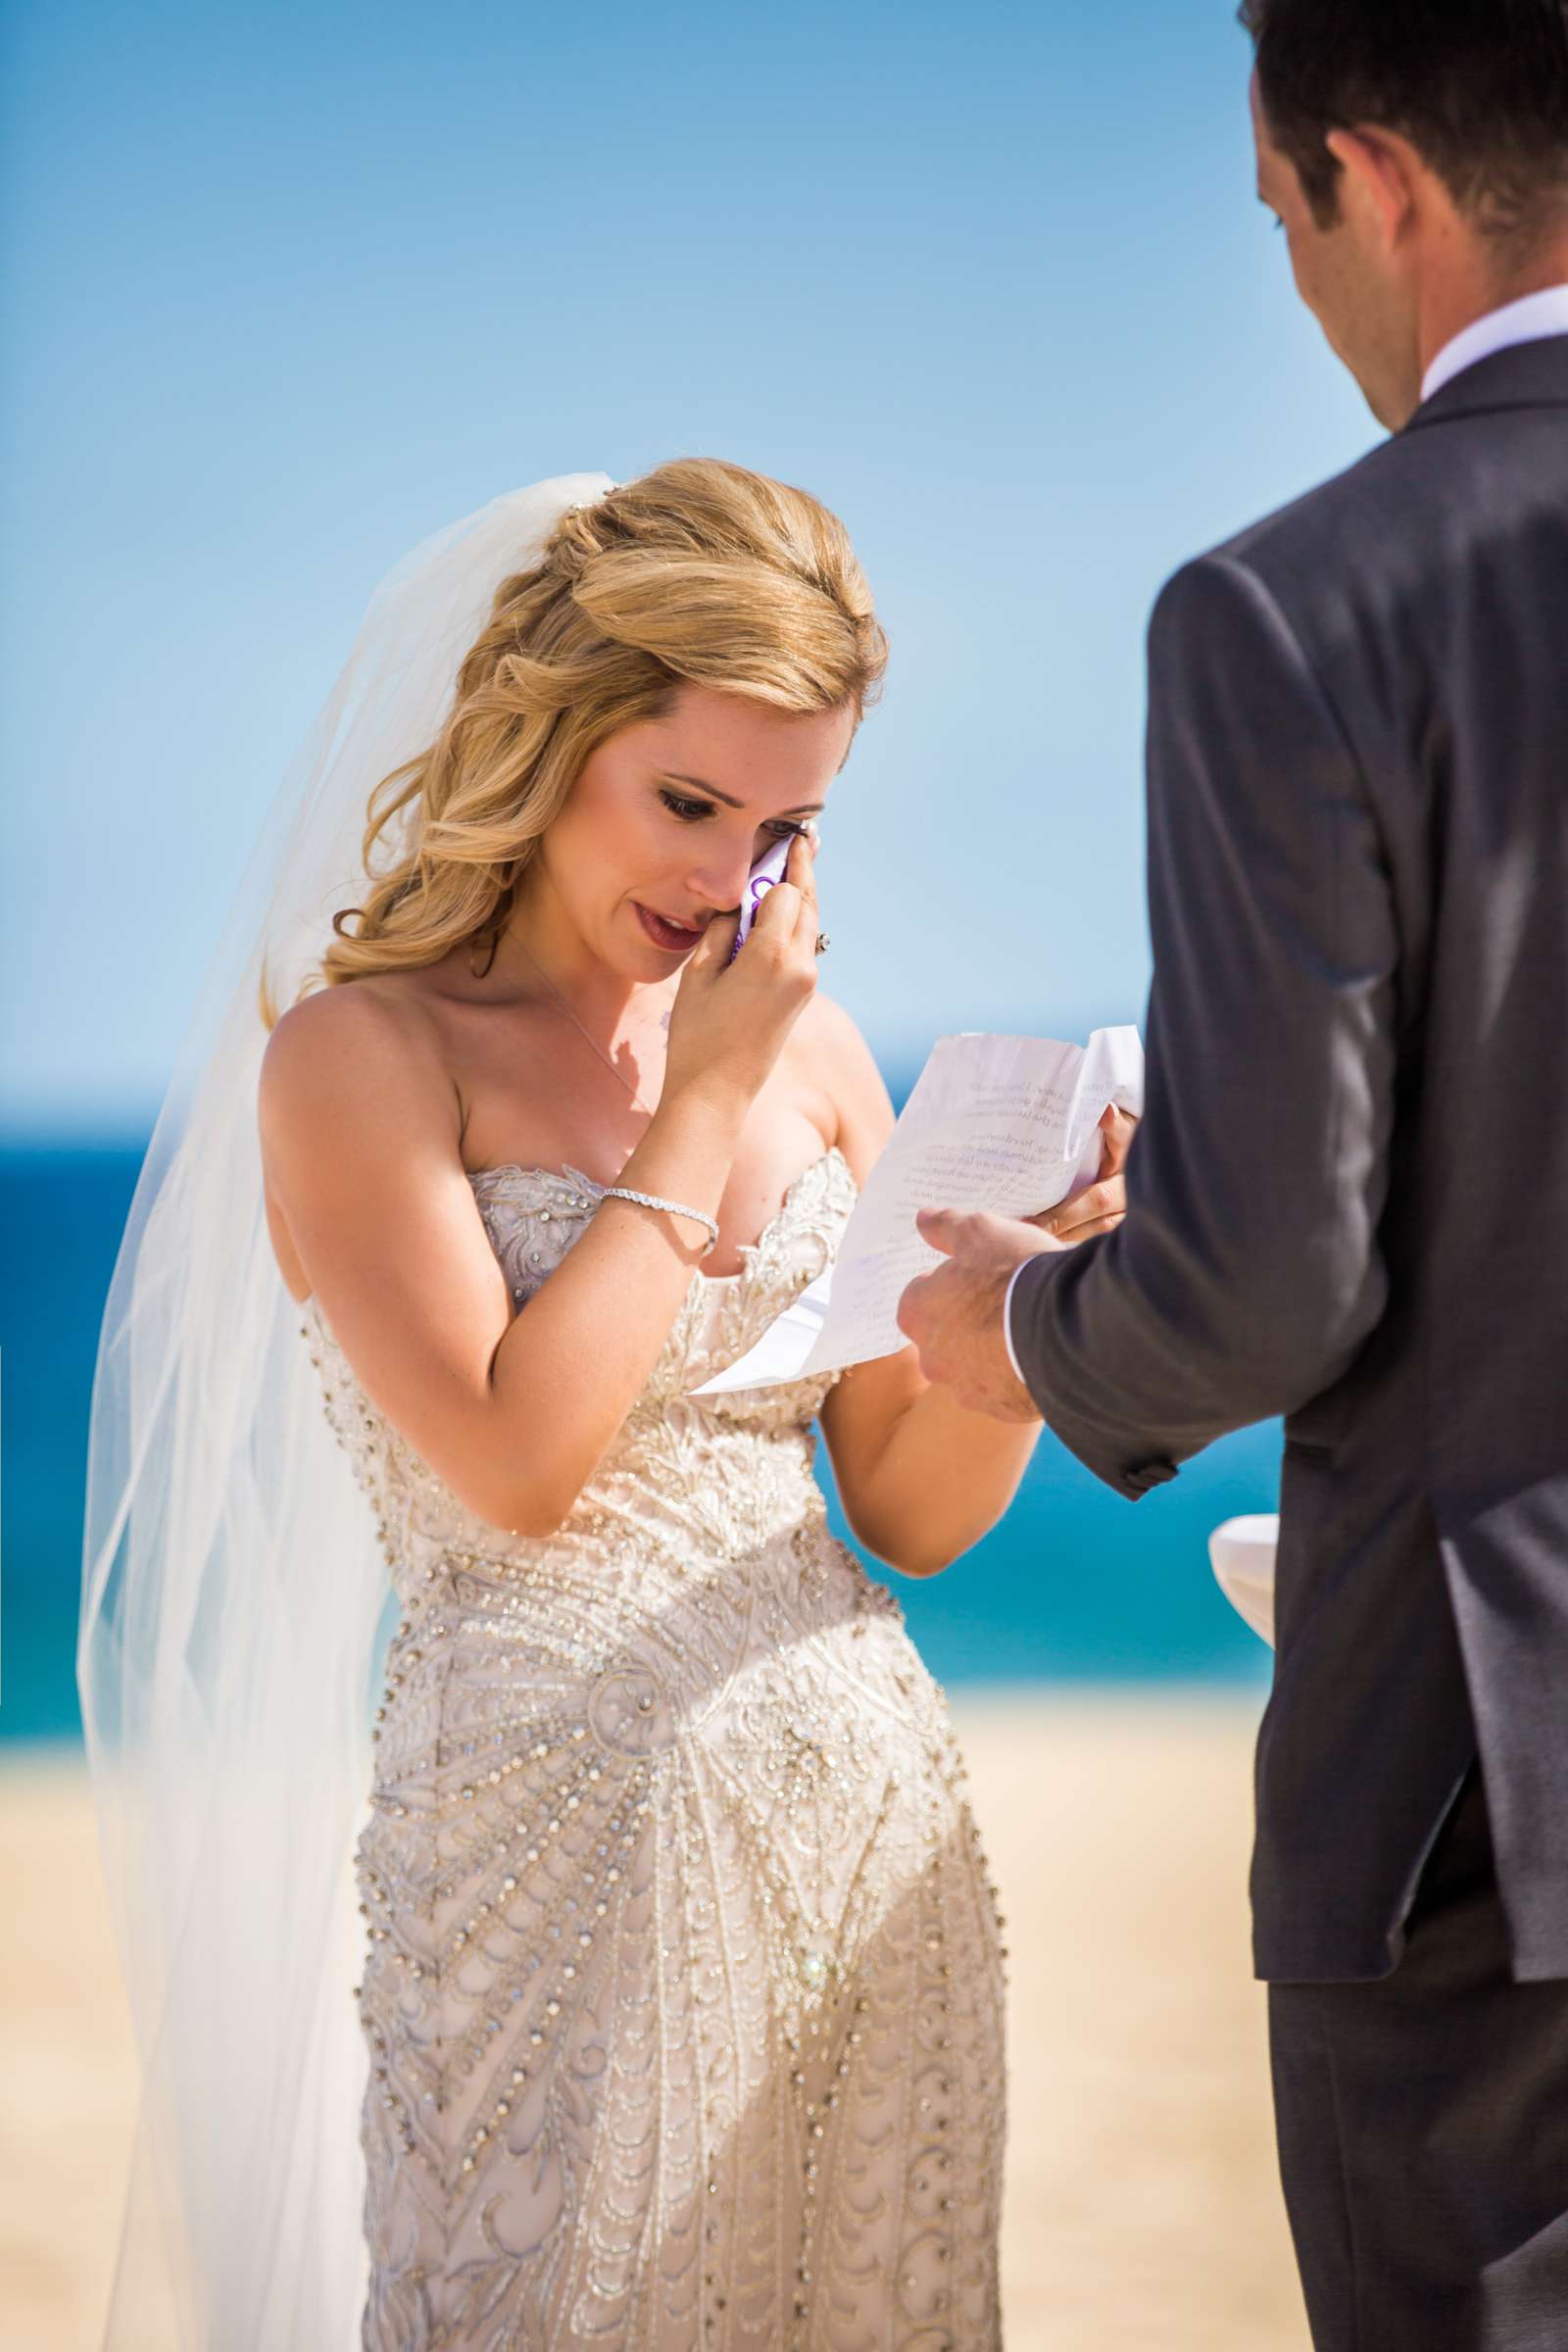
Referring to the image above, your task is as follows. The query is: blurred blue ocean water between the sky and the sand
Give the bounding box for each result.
[0,1139,1279,1740]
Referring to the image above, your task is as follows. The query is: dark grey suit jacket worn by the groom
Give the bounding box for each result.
[1010,336,1568,1981]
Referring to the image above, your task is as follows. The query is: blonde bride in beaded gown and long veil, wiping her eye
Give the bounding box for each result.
[80,461,1114,2352]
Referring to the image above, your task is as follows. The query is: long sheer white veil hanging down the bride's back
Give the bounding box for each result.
[77,472,613,2352]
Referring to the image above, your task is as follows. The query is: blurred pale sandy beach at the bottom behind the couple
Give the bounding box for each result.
[0,1691,1307,2352]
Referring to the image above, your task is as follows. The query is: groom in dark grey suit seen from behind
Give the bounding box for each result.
[901,0,1568,2352]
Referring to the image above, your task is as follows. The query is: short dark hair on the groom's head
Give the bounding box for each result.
[1242,0,1568,235]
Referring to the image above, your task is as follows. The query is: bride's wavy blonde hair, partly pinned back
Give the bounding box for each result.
[261,459,886,1030]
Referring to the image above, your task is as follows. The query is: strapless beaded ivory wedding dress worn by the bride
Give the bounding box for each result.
[301,1151,1004,2352]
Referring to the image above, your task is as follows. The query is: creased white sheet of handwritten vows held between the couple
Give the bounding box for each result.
[696,1028,1143,1397]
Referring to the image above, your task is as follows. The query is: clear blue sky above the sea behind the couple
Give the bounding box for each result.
[0,0,1378,1131]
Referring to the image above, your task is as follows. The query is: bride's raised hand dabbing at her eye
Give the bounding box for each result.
[661,833,818,1112]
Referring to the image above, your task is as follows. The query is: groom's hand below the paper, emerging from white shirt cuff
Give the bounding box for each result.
[898,1209,1067,1421]
